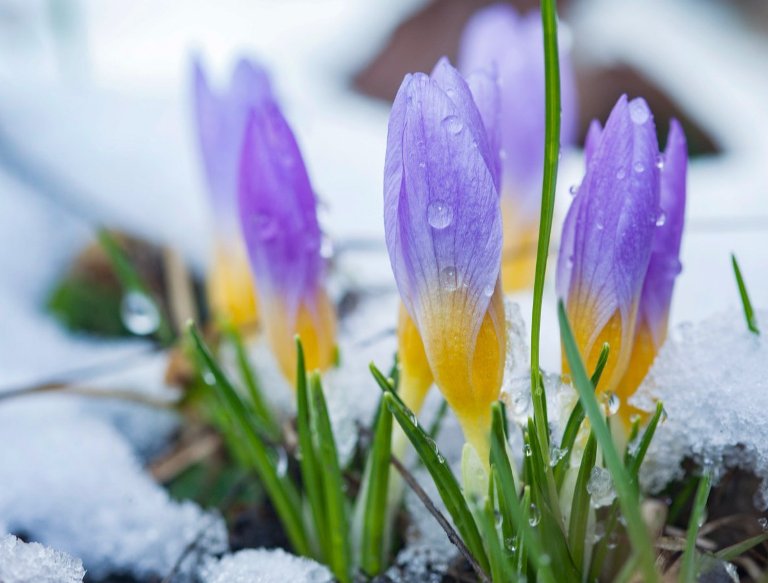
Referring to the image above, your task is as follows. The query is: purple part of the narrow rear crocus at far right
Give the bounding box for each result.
[639,119,688,348]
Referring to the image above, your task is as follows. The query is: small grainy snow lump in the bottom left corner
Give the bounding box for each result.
[0,534,85,583]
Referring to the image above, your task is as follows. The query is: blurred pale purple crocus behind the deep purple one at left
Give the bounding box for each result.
[194,60,271,324]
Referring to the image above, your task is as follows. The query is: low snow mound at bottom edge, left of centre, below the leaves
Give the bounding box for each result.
[200,549,334,583]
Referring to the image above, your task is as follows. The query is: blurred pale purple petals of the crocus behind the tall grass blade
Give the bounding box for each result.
[459,4,576,215]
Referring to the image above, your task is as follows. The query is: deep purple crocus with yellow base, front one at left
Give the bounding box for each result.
[239,92,336,381]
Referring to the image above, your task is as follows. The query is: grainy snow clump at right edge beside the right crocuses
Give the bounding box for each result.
[633,310,768,510]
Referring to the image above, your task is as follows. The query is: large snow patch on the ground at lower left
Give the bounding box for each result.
[0,397,227,578]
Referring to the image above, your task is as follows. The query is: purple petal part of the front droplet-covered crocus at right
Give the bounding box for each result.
[558,96,659,346]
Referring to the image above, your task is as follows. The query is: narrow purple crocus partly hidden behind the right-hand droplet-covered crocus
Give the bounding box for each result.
[619,120,688,404]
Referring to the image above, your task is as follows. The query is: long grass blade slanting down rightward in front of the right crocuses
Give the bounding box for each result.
[557,301,658,583]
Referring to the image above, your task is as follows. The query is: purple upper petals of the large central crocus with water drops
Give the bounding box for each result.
[384,69,502,343]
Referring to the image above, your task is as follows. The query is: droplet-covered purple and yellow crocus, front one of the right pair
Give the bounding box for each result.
[557,96,660,406]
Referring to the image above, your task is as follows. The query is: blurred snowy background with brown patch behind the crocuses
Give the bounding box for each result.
[0,0,768,390]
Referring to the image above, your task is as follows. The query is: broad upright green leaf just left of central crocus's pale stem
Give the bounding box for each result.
[360,399,392,577]
